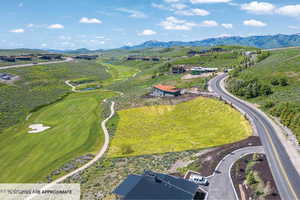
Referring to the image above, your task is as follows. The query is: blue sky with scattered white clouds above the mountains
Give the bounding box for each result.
[0,0,300,49]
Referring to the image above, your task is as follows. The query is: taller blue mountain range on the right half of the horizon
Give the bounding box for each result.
[121,34,300,50]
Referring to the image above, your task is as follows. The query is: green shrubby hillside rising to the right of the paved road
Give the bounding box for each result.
[232,48,300,142]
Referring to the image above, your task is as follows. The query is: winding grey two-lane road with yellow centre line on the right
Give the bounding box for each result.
[209,74,300,200]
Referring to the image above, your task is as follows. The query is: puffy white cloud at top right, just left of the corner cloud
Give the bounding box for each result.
[241,1,276,14]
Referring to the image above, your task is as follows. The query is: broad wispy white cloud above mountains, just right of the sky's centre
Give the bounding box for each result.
[160,17,197,31]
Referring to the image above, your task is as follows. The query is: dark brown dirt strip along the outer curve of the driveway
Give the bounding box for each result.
[182,136,261,176]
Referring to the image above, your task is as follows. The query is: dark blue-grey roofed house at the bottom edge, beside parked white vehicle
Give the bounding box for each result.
[113,171,201,200]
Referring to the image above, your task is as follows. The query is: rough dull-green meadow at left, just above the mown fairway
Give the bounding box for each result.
[0,61,111,134]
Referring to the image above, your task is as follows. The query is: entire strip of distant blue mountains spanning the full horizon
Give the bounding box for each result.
[4,33,300,54]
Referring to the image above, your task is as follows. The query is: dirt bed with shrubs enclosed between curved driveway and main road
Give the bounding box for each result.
[231,154,281,200]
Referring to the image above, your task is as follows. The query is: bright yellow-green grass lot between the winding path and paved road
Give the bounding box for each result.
[108,97,251,157]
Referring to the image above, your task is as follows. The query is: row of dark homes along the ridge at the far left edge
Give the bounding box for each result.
[0,54,62,62]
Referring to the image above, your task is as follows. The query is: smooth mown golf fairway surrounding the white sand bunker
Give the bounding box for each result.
[0,92,114,183]
